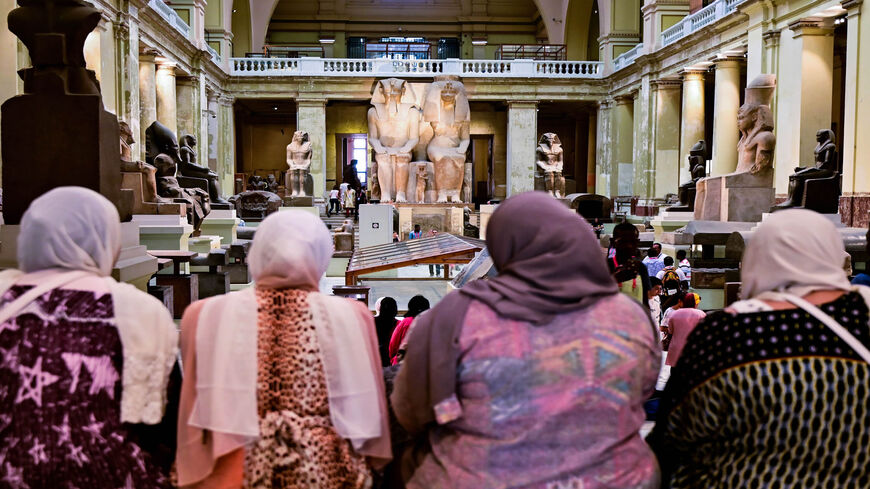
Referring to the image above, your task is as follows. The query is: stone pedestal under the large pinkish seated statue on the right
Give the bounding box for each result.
[695,169,776,222]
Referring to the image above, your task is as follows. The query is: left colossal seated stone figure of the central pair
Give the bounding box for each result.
[368,78,420,202]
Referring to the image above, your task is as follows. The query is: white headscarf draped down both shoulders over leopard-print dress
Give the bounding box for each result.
[191,210,391,476]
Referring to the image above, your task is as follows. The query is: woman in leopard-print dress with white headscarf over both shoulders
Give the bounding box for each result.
[177,211,392,488]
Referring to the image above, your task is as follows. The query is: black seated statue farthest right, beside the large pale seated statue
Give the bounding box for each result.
[774,129,840,211]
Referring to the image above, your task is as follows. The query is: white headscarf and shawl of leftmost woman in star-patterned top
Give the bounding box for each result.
[0,187,178,424]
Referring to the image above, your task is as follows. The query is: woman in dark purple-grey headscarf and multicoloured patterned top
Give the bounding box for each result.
[390,192,661,489]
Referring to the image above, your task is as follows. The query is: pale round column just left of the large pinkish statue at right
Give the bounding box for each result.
[711,57,740,175]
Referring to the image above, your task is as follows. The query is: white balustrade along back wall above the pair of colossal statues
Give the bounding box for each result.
[230,58,603,78]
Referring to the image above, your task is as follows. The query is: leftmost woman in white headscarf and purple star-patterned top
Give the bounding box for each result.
[0,187,178,488]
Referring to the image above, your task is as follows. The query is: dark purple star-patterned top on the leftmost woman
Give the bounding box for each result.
[0,285,170,489]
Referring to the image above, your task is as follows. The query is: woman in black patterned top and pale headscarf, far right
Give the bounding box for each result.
[647,210,870,489]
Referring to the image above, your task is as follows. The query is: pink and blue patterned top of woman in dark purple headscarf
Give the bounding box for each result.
[413,294,660,488]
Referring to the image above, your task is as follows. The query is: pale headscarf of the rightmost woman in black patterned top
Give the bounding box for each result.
[741,209,850,300]
